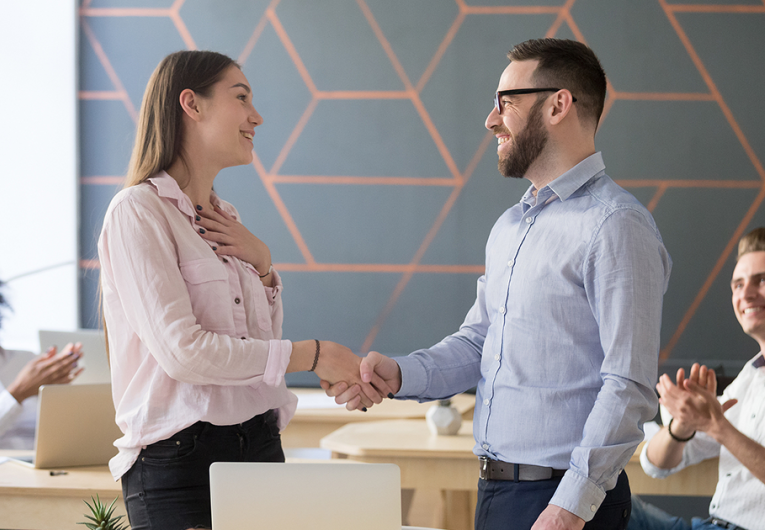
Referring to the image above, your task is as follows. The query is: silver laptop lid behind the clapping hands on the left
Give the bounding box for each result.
[38,329,111,385]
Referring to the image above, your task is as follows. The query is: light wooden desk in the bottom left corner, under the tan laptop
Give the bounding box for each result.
[0,451,127,530]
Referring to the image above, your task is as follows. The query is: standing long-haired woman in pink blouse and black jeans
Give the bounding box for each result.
[98,51,390,530]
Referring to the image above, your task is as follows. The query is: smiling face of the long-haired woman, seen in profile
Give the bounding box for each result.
[200,66,263,168]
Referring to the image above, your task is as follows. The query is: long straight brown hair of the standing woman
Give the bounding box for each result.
[125,51,239,188]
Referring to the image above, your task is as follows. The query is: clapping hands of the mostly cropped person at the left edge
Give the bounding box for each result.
[8,342,83,403]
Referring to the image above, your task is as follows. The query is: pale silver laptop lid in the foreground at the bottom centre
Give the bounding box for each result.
[210,462,401,530]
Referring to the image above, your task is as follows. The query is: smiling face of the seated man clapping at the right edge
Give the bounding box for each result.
[730,251,765,349]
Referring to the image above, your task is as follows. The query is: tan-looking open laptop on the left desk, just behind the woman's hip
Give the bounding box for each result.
[13,384,122,469]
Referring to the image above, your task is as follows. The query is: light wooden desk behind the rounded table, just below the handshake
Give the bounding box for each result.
[282,388,475,448]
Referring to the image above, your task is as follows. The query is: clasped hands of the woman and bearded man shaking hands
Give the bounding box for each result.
[288,341,401,412]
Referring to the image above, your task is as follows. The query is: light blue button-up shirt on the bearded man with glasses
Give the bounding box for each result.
[396,153,672,521]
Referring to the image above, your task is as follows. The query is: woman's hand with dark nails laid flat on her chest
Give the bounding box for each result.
[197,206,271,276]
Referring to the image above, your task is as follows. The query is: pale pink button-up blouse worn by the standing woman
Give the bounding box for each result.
[98,172,297,480]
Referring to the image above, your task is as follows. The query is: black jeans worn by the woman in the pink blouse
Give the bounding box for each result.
[122,411,284,530]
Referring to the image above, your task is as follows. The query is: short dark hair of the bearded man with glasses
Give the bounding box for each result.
[507,39,606,128]
